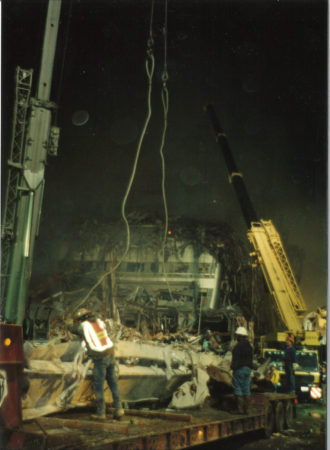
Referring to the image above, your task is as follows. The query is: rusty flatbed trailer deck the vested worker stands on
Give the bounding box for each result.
[18,393,295,450]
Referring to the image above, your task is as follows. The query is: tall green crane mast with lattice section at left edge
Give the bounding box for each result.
[1,0,62,324]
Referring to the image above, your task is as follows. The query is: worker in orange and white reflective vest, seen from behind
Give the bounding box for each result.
[68,308,124,419]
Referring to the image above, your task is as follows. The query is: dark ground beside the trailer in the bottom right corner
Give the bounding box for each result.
[194,403,330,450]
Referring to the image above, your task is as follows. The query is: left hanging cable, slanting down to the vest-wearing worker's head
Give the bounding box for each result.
[75,0,155,309]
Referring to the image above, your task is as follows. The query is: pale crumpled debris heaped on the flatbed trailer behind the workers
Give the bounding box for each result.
[23,306,274,419]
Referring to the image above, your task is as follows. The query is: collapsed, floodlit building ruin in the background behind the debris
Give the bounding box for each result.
[27,220,265,338]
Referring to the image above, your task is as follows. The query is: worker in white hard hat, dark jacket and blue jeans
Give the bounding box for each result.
[231,327,253,414]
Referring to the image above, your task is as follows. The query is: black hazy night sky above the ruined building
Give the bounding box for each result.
[2,0,328,308]
